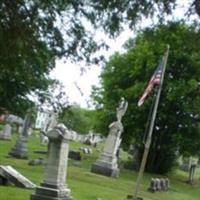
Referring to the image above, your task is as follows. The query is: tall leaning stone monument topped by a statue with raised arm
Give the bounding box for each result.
[91,98,128,177]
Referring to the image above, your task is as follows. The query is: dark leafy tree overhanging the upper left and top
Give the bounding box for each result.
[0,0,199,113]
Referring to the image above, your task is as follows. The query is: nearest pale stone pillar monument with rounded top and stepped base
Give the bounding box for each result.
[31,127,72,200]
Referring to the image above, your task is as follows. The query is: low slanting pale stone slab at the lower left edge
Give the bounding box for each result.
[0,165,35,188]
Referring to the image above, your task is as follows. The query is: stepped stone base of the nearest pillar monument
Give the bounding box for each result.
[31,184,72,200]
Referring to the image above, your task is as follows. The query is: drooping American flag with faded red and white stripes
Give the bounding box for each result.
[138,59,163,106]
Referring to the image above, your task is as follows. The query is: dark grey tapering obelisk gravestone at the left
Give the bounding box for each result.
[8,110,31,159]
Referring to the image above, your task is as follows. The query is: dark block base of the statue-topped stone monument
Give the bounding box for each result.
[91,161,119,177]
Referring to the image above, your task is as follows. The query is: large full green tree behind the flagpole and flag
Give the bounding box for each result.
[94,22,200,173]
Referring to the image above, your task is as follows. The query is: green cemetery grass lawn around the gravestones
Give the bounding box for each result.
[0,134,200,200]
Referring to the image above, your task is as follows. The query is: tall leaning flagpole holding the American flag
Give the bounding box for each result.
[132,45,169,200]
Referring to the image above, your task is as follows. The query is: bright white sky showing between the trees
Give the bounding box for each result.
[51,0,195,108]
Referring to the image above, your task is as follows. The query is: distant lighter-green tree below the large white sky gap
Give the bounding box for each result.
[59,104,94,134]
